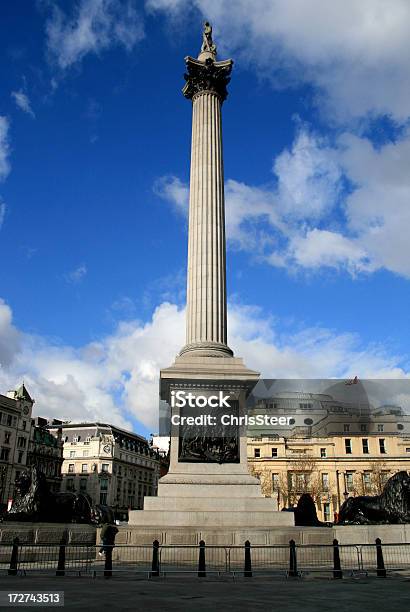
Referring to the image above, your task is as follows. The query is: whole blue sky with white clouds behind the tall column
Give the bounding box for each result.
[0,0,410,433]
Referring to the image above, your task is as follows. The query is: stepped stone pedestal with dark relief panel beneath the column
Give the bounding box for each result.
[129,354,294,544]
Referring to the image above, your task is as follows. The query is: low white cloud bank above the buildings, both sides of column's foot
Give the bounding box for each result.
[0,302,409,429]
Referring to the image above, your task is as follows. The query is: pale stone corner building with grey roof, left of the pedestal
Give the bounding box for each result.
[48,421,160,520]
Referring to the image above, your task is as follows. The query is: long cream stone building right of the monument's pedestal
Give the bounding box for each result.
[248,393,410,521]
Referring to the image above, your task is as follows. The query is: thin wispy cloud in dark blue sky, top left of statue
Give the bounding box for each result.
[46,0,144,70]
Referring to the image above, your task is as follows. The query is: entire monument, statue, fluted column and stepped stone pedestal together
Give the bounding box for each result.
[129,23,294,544]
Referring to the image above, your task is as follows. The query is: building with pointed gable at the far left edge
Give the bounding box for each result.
[0,384,34,510]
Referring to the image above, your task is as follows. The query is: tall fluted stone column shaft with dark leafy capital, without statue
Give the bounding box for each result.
[181,58,232,356]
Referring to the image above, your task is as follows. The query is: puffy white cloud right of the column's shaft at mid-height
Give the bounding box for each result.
[156,126,410,278]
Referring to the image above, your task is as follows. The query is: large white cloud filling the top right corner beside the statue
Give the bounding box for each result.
[146,0,410,121]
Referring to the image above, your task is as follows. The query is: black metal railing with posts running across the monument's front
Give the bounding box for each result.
[0,538,410,578]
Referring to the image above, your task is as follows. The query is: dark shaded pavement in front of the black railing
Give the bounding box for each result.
[0,575,410,612]
